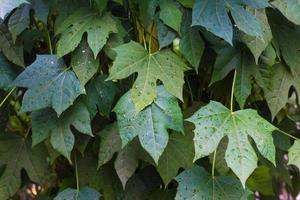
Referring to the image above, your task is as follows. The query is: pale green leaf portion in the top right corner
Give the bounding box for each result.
[271,0,300,25]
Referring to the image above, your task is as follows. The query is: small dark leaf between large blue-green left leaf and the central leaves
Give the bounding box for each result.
[85,75,118,117]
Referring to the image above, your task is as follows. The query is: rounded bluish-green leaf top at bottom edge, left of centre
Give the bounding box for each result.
[54,187,101,200]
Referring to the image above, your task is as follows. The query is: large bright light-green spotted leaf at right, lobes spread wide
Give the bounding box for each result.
[187,101,277,186]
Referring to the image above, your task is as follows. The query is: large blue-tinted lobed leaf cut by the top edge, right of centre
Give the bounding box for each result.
[192,0,263,44]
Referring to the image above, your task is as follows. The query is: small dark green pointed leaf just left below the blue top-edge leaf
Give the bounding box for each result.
[179,28,205,71]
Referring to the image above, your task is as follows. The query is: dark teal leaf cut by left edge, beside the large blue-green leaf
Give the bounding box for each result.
[0,53,18,91]
